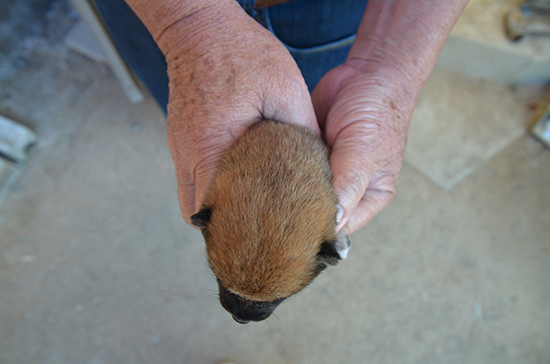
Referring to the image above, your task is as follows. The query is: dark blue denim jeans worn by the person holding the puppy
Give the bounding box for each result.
[95,0,367,113]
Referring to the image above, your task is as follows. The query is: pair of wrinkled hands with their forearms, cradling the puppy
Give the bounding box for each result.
[122,0,467,233]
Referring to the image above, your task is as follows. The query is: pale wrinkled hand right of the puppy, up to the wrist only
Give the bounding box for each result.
[312,62,416,233]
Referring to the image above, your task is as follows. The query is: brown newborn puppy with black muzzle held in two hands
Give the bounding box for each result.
[191,120,350,324]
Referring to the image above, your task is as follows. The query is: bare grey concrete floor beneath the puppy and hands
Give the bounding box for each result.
[0,0,550,364]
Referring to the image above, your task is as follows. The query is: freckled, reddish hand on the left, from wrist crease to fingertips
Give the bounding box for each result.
[157,0,319,223]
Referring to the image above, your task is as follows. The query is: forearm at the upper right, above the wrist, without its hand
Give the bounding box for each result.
[347,0,468,93]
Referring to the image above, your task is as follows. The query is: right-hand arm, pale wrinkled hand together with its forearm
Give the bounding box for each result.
[312,0,468,233]
